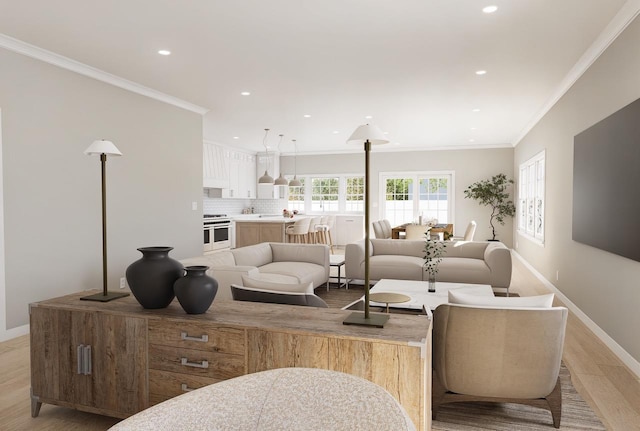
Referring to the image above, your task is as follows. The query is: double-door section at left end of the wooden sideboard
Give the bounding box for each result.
[30,307,148,417]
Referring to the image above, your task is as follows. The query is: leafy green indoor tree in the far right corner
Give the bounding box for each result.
[464,174,516,241]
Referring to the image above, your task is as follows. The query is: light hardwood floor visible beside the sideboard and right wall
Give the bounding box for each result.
[0,259,640,431]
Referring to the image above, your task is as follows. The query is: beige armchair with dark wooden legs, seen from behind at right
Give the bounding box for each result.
[432,304,568,428]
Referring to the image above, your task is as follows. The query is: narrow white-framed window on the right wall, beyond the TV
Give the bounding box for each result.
[518,151,545,243]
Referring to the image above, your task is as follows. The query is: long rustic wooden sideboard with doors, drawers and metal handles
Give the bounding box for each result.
[30,291,431,430]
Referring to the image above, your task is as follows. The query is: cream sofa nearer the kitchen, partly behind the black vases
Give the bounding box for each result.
[180,242,330,300]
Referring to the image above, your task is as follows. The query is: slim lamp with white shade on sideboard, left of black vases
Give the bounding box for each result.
[80,139,129,302]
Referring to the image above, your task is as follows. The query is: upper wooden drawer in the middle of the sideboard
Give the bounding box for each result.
[148,320,245,355]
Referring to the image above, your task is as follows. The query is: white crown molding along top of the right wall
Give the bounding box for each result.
[513,0,640,147]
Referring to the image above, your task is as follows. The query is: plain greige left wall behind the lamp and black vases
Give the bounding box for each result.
[0,49,202,329]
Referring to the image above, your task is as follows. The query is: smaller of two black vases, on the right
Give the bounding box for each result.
[173,266,218,314]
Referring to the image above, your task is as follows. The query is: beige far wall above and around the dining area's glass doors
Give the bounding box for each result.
[280,147,515,247]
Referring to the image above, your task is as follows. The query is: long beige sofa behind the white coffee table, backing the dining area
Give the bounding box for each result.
[345,238,511,289]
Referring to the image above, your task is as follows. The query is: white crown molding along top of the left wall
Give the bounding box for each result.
[0,33,209,115]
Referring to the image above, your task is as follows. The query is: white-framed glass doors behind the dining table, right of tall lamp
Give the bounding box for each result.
[382,172,453,226]
